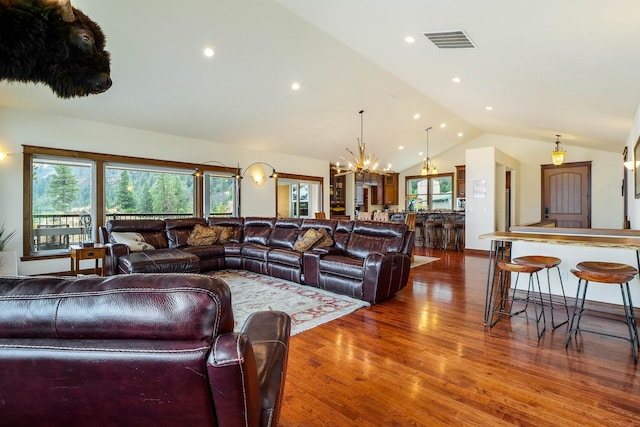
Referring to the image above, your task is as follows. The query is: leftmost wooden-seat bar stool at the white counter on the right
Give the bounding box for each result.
[489,262,546,339]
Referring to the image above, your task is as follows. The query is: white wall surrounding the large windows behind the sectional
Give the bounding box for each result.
[0,108,329,274]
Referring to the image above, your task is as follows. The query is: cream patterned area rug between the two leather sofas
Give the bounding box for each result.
[212,270,369,335]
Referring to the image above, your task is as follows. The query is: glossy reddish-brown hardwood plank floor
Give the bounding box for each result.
[280,248,640,426]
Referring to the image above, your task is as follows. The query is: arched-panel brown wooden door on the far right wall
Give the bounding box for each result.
[542,162,591,228]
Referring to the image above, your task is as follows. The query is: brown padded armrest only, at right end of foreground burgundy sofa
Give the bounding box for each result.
[242,311,291,426]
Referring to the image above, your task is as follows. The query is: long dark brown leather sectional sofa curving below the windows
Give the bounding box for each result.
[99,217,413,304]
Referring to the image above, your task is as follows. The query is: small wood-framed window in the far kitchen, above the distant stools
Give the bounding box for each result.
[405,173,453,211]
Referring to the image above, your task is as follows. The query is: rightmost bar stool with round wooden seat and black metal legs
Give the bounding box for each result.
[565,261,640,363]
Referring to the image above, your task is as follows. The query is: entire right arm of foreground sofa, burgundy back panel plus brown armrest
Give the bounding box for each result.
[207,311,291,427]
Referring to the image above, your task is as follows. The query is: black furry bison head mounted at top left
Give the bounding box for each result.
[0,0,111,98]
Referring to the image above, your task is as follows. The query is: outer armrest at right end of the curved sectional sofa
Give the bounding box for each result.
[362,252,411,304]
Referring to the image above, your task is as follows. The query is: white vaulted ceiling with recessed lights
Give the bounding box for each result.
[0,0,640,171]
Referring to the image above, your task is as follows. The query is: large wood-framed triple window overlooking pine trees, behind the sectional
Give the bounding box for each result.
[22,145,240,260]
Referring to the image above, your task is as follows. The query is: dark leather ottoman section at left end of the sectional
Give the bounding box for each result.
[118,249,200,274]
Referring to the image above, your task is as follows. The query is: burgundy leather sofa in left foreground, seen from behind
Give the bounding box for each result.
[0,274,291,427]
